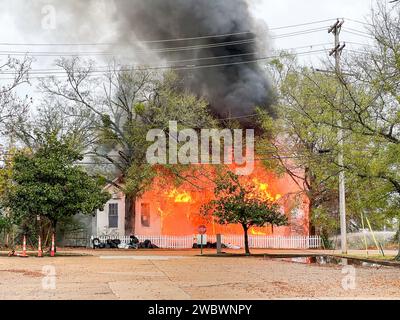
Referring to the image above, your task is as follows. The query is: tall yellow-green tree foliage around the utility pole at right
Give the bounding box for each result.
[260,40,399,248]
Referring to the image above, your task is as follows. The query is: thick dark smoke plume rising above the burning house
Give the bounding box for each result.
[115,0,272,124]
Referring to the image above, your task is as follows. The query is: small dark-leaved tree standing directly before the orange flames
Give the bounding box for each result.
[202,171,288,255]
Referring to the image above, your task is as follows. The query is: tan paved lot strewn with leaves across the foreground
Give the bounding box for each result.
[0,250,400,300]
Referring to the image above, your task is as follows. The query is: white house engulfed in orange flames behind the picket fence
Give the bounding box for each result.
[95,162,310,237]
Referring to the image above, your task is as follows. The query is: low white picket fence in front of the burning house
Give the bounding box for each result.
[92,235,321,249]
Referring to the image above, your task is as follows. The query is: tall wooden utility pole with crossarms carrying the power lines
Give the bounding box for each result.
[328,20,347,254]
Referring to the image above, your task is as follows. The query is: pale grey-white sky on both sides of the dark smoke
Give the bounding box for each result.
[0,0,386,101]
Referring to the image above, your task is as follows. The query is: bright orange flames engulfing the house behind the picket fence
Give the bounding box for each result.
[137,162,309,236]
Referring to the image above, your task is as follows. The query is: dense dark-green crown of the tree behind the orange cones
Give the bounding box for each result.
[3,132,110,251]
